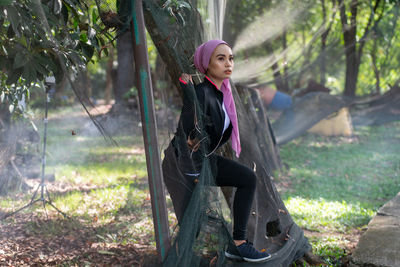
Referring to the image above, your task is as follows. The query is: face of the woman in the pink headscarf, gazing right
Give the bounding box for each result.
[206,44,234,83]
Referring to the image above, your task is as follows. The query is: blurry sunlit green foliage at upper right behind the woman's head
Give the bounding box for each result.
[228,0,400,95]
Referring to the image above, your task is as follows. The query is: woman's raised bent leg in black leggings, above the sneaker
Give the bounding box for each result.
[215,156,257,240]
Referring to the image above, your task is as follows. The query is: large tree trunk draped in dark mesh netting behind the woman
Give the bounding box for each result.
[134,1,310,266]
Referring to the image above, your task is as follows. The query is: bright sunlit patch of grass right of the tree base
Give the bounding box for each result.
[285,197,374,233]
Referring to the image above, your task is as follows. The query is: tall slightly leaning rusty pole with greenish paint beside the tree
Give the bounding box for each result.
[131,0,170,260]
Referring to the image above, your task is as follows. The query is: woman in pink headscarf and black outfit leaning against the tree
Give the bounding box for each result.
[163,40,271,262]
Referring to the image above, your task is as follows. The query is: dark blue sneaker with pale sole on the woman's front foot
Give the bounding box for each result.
[225,241,271,262]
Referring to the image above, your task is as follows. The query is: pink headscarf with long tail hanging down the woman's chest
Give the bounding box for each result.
[194,40,242,158]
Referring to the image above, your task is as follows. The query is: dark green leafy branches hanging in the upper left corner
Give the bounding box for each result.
[0,0,112,114]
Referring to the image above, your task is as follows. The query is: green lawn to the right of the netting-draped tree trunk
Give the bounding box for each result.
[277,122,400,266]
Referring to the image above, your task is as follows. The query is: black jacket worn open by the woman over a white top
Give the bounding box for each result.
[172,77,232,173]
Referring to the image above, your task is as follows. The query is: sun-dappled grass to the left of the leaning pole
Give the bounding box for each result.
[0,107,164,253]
